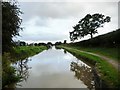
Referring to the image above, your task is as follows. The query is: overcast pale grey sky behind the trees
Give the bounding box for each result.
[14,0,118,43]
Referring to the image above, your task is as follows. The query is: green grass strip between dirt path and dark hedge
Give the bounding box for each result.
[64,45,120,62]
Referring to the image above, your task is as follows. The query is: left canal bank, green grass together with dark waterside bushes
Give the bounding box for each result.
[2,46,47,88]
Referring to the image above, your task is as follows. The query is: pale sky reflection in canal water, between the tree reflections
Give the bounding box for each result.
[17,48,90,88]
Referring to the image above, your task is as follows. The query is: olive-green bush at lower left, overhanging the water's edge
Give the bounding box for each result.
[2,53,20,88]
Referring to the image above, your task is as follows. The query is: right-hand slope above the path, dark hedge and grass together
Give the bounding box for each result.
[67,29,120,62]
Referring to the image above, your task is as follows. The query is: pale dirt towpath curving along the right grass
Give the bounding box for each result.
[79,50,120,70]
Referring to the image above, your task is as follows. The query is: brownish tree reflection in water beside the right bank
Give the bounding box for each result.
[70,62,94,89]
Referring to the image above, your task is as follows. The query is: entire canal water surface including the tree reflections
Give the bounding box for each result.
[14,47,94,89]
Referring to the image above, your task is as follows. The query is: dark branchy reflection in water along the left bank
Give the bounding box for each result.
[16,58,31,81]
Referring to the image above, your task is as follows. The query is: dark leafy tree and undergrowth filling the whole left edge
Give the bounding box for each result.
[2,0,22,88]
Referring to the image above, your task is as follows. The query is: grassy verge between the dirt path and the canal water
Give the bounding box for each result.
[59,46,120,88]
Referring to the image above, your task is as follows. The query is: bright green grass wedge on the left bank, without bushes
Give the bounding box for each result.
[12,46,47,61]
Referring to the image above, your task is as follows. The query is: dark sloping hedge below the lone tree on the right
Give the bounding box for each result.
[70,29,120,48]
